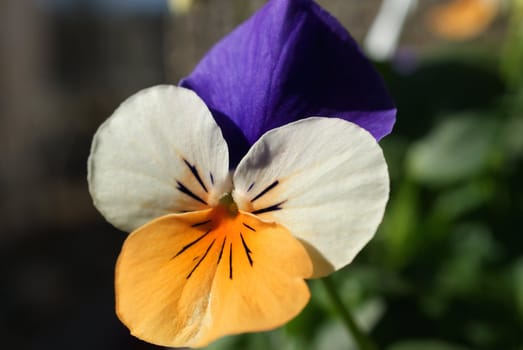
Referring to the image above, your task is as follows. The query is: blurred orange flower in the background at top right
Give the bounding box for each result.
[428,0,500,40]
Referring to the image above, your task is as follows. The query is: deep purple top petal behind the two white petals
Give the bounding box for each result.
[181,0,396,163]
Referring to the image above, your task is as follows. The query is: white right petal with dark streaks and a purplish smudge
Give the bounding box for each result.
[233,117,389,277]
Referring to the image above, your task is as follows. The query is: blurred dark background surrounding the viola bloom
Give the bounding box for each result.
[0,0,523,350]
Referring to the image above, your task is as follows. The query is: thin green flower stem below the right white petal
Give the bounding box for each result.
[321,277,377,350]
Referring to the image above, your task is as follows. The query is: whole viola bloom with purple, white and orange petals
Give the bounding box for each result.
[88,0,395,347]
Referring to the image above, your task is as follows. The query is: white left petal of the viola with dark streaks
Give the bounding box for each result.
[88,86,230,231]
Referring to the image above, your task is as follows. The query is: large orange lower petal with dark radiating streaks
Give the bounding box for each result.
[115,208,312,347]
